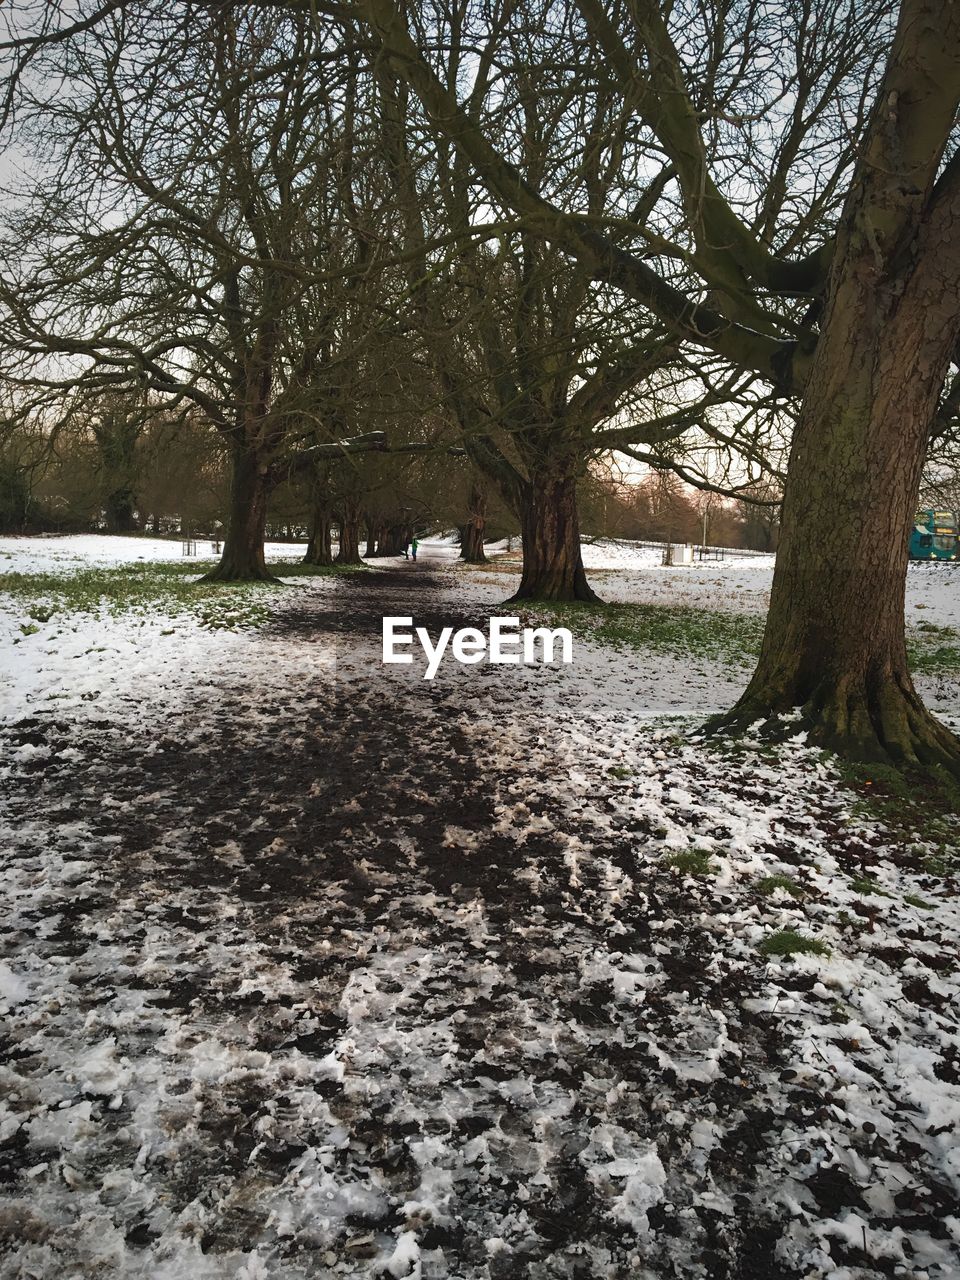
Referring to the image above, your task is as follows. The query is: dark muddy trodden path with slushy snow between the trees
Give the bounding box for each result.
[0,564,911,1280]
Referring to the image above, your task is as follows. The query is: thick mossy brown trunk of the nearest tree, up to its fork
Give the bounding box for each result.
[718,52,960,776]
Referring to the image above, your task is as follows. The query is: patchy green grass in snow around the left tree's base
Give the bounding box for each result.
[0,561,355,639]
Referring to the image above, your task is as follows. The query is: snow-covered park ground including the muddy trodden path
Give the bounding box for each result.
[0,538,960,1280]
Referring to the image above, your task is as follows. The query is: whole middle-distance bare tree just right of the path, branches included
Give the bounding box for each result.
[378,12,783,600]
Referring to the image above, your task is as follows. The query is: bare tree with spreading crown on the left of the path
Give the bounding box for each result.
[0,5,401,580]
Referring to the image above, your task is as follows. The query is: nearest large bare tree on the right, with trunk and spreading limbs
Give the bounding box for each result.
[357,0,960,773]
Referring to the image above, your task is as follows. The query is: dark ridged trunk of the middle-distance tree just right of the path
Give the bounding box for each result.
[511,466,598,603]
